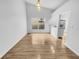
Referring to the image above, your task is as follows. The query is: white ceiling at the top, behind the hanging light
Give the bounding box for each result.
[26,0,68,9]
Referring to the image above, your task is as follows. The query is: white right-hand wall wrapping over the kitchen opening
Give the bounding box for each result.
[50,0,79,55]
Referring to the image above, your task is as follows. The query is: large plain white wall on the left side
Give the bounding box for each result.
[0,0,27,58]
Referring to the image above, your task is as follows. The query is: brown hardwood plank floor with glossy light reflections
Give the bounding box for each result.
[2,33,79,59]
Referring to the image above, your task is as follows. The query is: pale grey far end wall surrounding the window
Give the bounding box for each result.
[27,3,51,33]
